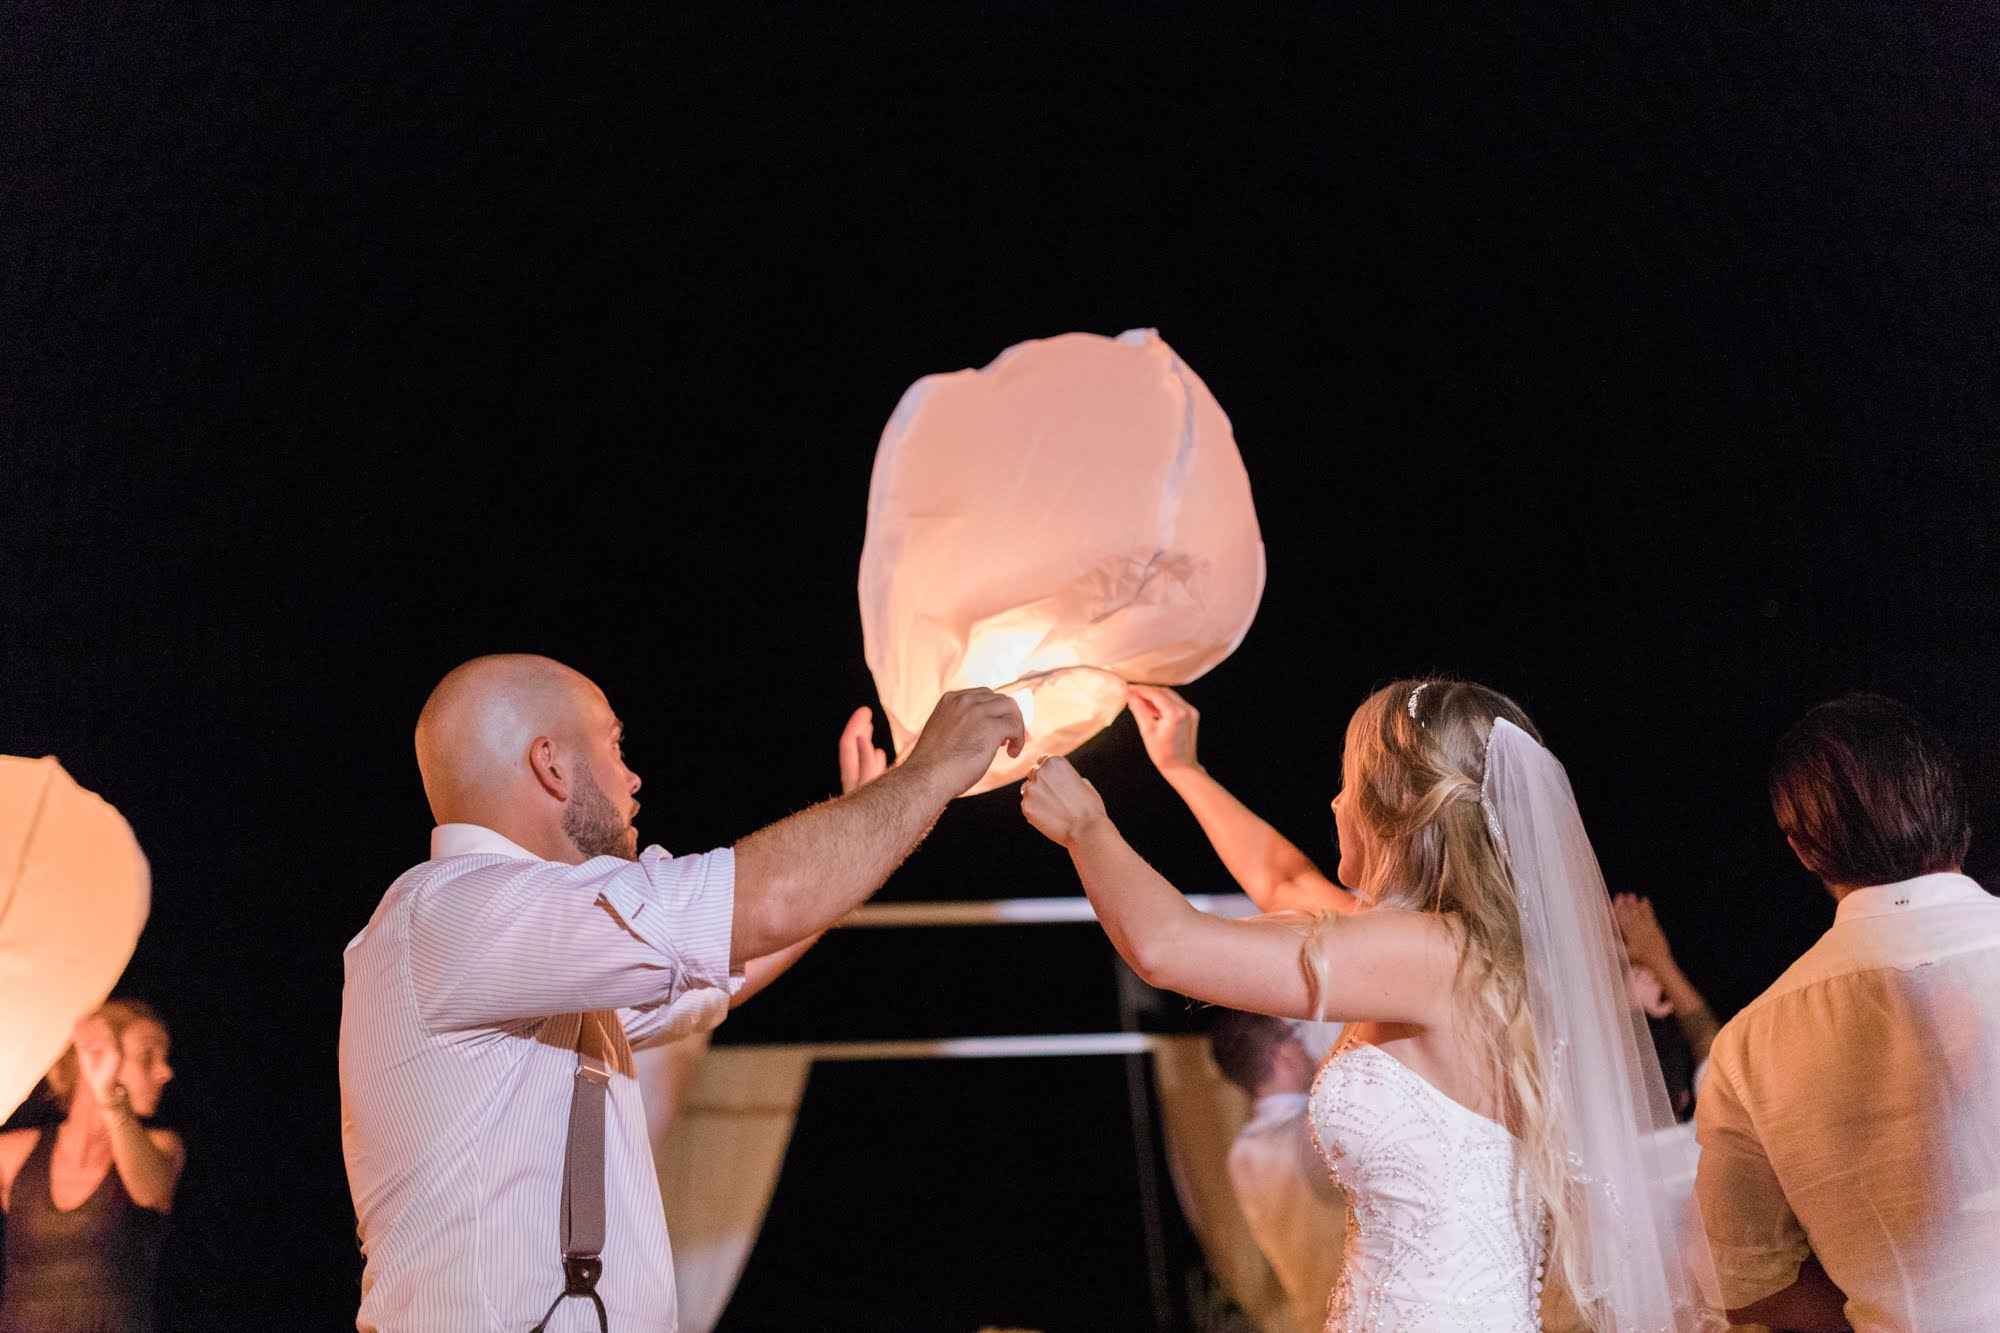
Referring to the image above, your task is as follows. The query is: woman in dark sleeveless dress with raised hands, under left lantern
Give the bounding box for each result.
[0,999,186,1333]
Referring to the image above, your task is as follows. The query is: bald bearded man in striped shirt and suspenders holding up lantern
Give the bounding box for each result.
[340,654,1024,1333]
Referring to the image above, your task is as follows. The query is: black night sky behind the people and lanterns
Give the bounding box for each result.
[0,2,2000,1329]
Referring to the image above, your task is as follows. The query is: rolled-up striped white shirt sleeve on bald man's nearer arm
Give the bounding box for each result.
[408,847,742,1031]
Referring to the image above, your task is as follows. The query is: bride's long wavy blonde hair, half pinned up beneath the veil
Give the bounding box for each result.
[1302,677,1580,1320]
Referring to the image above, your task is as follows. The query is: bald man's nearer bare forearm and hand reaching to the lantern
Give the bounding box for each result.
[730,691,1026,967]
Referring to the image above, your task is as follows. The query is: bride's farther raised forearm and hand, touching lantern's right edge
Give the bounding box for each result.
[1126,685,1358,913]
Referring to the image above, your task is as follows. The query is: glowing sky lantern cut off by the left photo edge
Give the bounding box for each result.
[0,755,152,1119]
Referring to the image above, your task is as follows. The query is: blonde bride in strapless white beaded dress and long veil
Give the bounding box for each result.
[1022,679,1720,1333]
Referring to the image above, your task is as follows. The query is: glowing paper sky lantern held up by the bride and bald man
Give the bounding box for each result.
[860,328,1264,793]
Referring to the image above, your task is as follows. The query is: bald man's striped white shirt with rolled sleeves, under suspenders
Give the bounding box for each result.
[340,825,742,1333]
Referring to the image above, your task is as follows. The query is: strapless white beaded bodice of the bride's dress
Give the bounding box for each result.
[1308,1041,1542,1333]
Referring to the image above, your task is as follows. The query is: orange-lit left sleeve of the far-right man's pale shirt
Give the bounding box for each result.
[1694,1040,1812,1309]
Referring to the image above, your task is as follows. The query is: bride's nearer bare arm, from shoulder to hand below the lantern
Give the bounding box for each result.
[1020,759,1458,1025]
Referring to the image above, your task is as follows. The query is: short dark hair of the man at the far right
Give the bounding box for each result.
[1770,695,1972,887]
